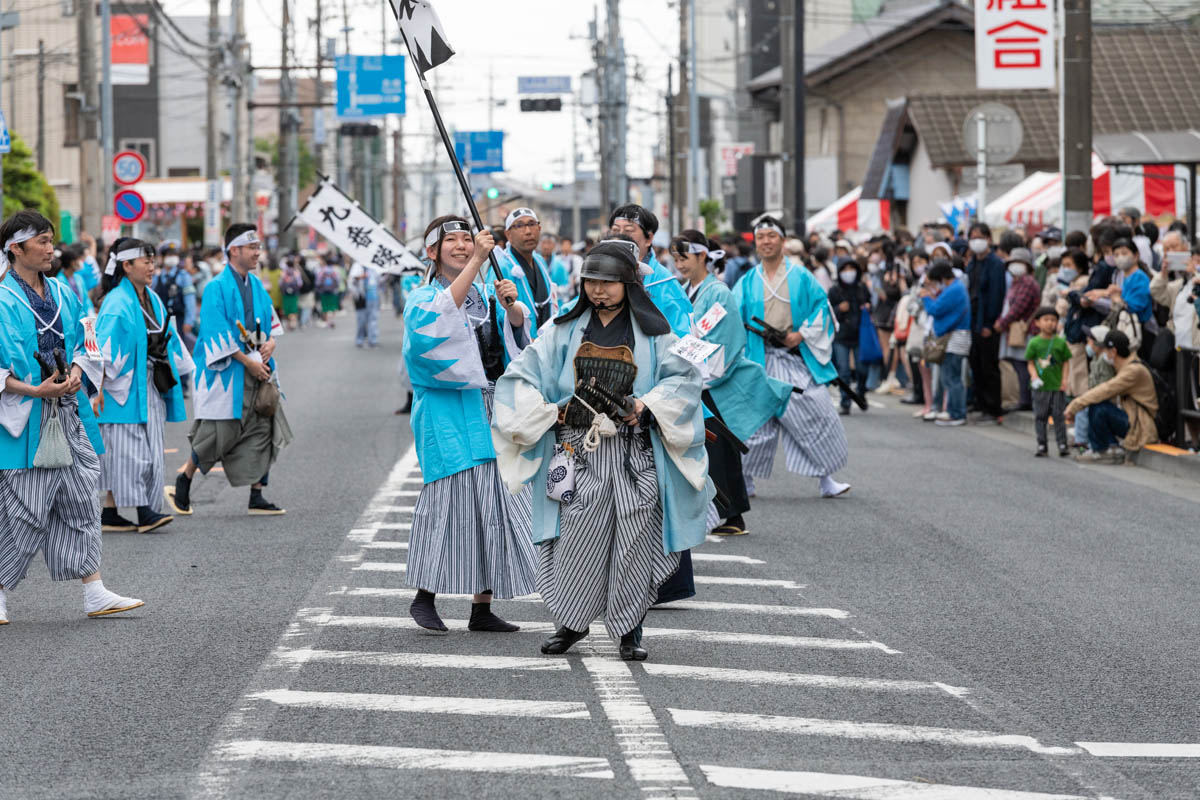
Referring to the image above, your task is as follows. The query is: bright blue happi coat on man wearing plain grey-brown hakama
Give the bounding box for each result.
[192,263,282,420]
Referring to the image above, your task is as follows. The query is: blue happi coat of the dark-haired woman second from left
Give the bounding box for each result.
[96,278,194,425]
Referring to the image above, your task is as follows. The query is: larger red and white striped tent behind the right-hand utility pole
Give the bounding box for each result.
[984,155,1188,228]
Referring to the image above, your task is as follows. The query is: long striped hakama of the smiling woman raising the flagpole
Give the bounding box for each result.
[406,389,534,600]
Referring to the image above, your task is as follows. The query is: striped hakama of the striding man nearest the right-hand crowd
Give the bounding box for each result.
[742,348,850,477]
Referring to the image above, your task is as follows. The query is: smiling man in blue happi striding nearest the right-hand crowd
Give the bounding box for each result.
[733,216,850,498]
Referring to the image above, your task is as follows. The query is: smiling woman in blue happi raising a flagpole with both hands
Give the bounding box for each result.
[404,216,535,632]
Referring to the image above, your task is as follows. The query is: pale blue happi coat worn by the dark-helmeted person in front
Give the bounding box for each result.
[492,309,715,553]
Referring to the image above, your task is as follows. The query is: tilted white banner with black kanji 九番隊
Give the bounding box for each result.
[296,178,425,275]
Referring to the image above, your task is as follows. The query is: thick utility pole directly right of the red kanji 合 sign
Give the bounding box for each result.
[1058,0,1094,234]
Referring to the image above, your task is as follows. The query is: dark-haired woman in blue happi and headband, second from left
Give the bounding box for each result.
[94,239,193,534]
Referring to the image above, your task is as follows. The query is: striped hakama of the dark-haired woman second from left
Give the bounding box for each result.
[100,363,167,513]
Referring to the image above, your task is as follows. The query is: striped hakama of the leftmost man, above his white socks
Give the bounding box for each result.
[0,396,101,590]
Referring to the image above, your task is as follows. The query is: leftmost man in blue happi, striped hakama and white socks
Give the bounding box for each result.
[0,210,144,625]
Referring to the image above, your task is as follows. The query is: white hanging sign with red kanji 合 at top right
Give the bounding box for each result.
[976,0,1057,89]
